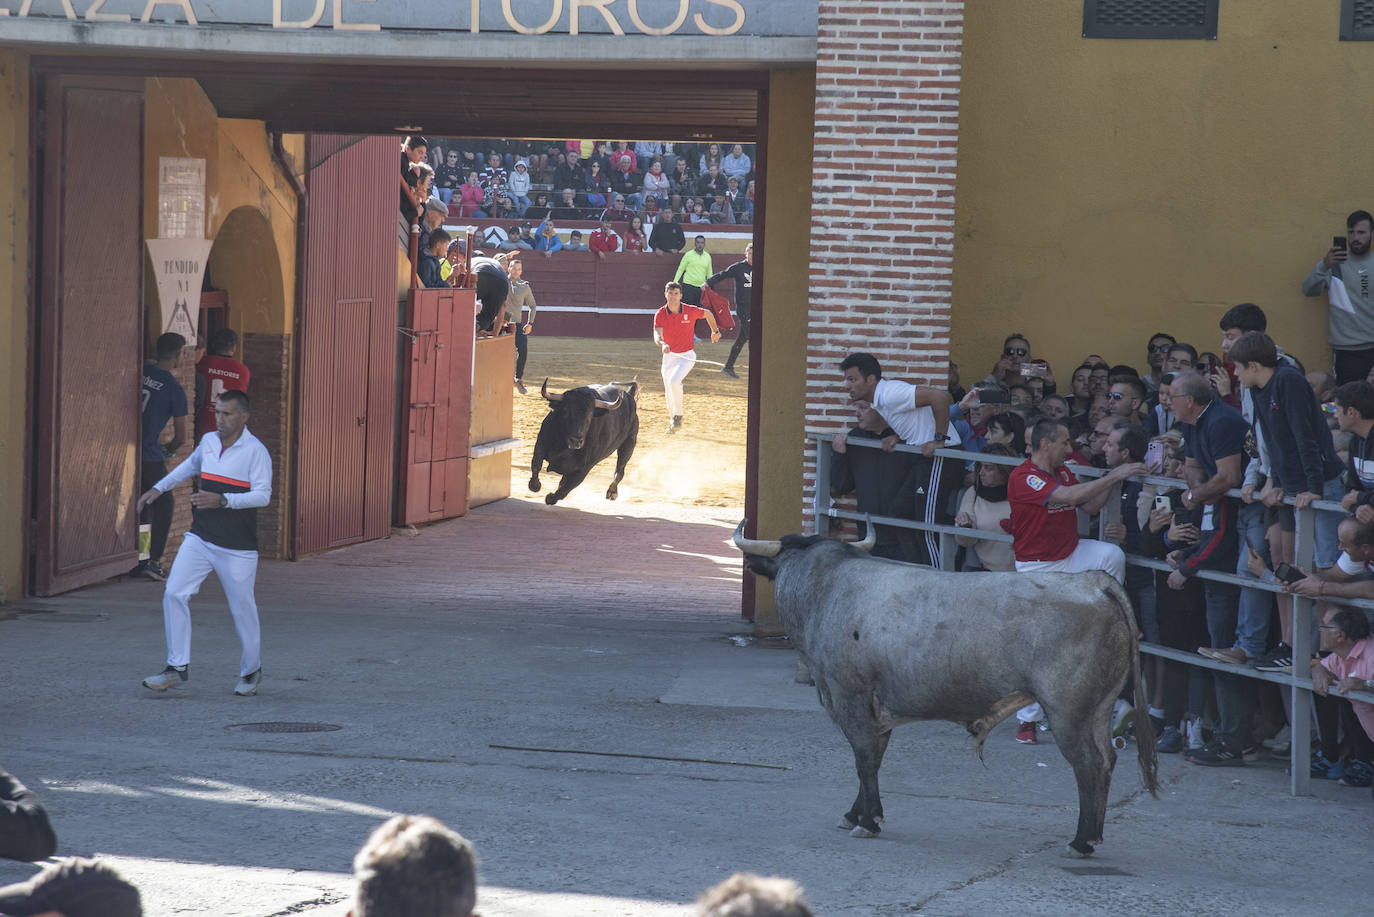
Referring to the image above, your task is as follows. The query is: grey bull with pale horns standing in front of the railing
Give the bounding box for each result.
[735,522,1158,857]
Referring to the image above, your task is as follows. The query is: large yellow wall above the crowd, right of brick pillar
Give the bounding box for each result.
[952,0,1357,390]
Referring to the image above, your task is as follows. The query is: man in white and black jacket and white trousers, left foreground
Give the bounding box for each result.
[137,389,272,697]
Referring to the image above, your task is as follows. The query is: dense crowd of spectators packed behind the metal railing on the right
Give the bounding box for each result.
[830,270,1374,788]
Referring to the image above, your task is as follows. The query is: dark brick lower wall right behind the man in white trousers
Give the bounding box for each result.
[242,333,291,558]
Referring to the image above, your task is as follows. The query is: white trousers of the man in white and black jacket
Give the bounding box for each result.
[162,532,262,675]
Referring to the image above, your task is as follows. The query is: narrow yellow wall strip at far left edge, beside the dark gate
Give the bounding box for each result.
[0,49,30,602]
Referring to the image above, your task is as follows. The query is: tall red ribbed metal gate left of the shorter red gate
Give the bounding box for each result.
[294,135,400,555]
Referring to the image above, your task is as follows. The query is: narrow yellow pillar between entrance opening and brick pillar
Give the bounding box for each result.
[750,69,816,635]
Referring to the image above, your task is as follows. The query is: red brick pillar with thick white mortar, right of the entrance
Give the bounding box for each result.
[805,0,963,514]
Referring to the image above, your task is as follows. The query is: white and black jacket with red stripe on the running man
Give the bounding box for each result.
[154,428,272,551]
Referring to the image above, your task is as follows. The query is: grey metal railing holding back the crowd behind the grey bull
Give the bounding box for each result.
[807,430,1374,796]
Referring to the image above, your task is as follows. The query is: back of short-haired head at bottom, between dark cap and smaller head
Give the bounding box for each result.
[350,815,477,917]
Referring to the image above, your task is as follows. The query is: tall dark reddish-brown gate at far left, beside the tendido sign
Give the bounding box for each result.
[30,76,143,595]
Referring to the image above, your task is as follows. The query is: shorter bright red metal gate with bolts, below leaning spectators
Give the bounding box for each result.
[397,290,477,524]
